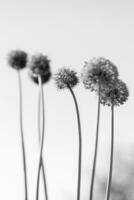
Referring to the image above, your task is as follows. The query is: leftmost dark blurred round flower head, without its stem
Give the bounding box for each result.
[8,50,28,70]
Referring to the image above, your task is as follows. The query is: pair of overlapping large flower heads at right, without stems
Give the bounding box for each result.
[81,57,129,106]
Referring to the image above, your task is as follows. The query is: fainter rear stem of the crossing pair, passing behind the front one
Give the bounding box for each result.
[38,90,48,200]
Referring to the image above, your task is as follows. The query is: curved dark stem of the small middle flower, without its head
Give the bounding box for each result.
[68,85,82,200]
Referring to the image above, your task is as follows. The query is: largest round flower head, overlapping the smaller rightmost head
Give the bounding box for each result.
[81,57,119,91]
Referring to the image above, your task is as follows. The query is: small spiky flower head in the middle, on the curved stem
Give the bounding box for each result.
[54,68,78,89]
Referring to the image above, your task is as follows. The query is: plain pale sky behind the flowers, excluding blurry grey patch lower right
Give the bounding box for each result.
[0,0,134,200]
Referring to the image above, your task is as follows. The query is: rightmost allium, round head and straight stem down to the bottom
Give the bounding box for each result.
[100,79,129,200]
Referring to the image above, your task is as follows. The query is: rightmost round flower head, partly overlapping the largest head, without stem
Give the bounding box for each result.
[100,79,129,106]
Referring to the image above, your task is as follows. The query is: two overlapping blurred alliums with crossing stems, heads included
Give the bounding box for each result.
[29,54,51,200]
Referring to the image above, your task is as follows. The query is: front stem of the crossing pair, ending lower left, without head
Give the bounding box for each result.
[36,76,45,200]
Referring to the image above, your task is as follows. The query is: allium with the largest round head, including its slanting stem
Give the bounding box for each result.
[81,57,118,200]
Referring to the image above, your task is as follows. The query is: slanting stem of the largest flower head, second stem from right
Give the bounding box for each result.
[89,84,100,200]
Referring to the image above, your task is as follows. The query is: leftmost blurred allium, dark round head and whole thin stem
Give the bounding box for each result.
[8,50,28,200]
